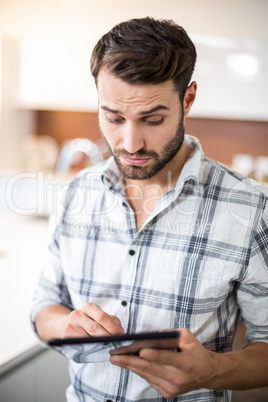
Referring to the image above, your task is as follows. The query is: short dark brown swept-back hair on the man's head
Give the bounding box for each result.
[90,17,196,100]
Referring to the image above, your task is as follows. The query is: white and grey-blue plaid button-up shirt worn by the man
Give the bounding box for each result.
[32,136,268,402]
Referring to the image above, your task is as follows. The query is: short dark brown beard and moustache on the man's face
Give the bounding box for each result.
[102,116,185,180]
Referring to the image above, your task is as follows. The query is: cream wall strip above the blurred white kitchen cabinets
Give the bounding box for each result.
[0,0,268,42]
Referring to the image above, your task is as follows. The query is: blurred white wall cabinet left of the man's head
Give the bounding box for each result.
[17,36,97,110]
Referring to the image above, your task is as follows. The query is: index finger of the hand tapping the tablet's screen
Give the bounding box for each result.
[82,303,124,335]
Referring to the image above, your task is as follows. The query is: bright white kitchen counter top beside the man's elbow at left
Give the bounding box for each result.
[0,211,48,366]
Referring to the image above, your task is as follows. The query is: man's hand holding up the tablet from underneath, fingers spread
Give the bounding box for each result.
[110,329,216,399]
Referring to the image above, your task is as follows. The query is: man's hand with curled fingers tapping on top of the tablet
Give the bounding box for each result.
[61,303,124,338]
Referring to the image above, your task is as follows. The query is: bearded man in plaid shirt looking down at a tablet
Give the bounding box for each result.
[32,18,268,402]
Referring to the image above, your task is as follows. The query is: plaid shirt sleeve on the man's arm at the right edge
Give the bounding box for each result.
[237,201,268,343]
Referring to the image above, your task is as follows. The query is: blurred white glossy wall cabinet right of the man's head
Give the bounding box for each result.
[191,34,268,121]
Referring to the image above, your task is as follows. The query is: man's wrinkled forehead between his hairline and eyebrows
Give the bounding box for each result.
[97,69,179,112]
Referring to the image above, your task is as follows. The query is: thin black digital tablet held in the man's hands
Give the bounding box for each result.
[47,331,180,363]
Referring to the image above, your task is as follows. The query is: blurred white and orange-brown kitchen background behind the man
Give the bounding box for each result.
[0,0,268,402]
